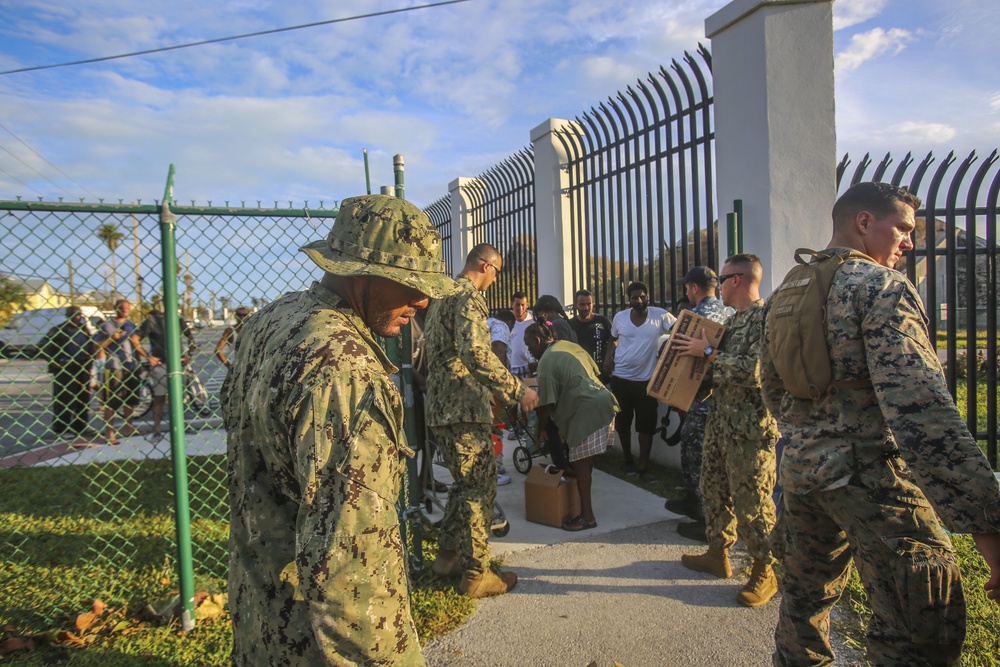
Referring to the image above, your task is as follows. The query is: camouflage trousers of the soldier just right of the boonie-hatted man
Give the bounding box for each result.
[431,424,497,572]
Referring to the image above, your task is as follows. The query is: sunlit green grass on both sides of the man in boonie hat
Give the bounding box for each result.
[0,457,475,667]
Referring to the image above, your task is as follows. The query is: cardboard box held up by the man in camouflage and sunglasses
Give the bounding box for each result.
[646,310,726,410]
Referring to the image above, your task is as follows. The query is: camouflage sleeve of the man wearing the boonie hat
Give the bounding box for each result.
[283,378,422,664]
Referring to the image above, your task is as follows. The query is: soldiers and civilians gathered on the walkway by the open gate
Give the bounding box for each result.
[215,183,1000,665]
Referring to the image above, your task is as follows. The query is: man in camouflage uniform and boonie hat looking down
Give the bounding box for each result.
[222,195,455,667]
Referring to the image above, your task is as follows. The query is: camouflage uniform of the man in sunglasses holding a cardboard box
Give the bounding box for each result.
[701,299,780,564]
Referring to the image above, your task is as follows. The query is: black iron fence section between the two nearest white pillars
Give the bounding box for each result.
[559,47,719,313]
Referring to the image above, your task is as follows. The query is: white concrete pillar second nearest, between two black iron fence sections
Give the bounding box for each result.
[531,118,579,305]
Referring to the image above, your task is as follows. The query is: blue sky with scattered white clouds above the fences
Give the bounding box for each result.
[0,0,1000,205]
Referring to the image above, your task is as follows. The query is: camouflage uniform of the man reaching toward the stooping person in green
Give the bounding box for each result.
[424,275,525,572]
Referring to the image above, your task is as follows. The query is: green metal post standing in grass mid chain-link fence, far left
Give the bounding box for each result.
[160,165,195,631]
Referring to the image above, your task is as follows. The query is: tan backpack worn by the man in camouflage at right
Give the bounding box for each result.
[766,248,875,400]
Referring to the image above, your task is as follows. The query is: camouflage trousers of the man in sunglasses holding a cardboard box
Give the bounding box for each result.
[701,426,778,563]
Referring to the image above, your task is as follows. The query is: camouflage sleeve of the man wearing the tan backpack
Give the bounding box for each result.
[856,272,1000,533]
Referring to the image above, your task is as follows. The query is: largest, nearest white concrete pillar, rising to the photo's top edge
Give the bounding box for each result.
[705,0,837,296]
